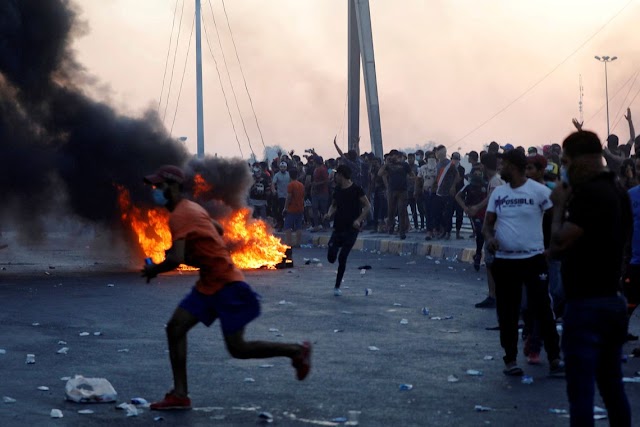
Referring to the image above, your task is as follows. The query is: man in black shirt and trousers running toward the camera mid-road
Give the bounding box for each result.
[325,165,371,296]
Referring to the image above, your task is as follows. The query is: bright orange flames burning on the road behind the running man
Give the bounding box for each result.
[118,186,287,269]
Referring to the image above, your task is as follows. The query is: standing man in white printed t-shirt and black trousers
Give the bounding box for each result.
[483,150,564,376]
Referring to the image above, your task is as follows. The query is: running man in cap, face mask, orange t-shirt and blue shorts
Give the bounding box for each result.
[142,165,311,410]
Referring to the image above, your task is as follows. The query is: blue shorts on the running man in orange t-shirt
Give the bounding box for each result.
[178,282,260,335]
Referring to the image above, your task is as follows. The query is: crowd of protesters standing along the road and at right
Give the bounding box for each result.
[239,109,640,425]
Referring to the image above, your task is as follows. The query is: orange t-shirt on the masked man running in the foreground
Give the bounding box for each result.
[169,199,244,295]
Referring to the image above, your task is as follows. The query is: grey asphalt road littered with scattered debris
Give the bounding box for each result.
[0,244,640,426]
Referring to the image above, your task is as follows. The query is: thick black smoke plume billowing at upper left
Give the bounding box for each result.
[0,0,189,237]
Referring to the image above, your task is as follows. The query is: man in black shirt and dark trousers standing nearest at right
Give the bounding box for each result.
[545,130,632,426]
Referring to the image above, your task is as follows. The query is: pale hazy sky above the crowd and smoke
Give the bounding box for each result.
[74,0,640,157]
